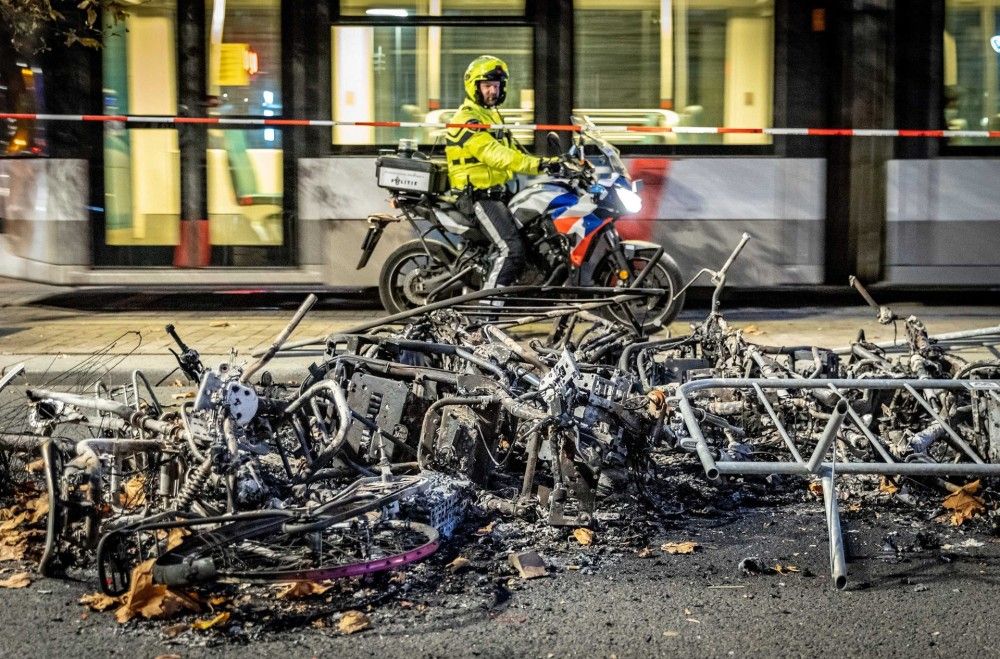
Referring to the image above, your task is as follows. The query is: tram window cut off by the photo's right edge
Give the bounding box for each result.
[943,0,1000,146]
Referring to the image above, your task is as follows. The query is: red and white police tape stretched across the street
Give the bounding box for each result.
[0,112,1000,139]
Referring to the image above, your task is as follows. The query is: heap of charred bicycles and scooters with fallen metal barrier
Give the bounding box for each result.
[0,239,1000,636]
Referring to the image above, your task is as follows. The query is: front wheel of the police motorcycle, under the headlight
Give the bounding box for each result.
[595,249,685,334]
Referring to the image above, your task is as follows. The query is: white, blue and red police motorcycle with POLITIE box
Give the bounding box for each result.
[357,117,684,331]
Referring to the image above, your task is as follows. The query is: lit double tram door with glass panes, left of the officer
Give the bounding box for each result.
[95,0,294,267]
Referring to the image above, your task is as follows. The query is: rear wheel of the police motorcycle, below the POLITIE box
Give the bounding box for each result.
[378,240,447,314]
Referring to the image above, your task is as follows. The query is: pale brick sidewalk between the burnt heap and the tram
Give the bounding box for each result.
[0,296,1000,378]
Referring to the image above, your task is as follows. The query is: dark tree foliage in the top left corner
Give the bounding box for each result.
[0,0,134,53]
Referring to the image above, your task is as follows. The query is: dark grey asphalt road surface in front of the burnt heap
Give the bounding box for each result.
[0,504,1000,657]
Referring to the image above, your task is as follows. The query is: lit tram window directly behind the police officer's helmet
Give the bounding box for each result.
[331,26,535,146]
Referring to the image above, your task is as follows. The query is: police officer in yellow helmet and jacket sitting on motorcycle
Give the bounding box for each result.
[445,55,560,288]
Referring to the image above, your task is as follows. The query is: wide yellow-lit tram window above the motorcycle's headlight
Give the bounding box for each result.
[574,0,774,144]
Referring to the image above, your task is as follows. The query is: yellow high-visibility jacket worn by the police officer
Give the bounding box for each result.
[444,99,539,189]
